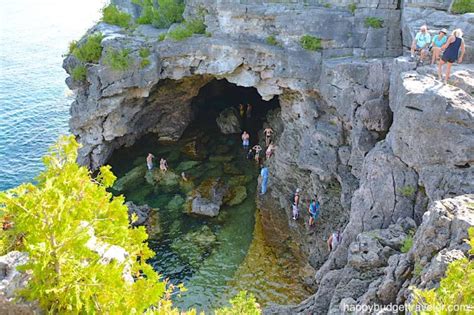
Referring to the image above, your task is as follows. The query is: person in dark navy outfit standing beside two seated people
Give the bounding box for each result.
[438,28,465,84]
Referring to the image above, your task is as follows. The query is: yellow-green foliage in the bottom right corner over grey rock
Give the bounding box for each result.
[410,228,474,314]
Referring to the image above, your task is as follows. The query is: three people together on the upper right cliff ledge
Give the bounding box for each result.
[411,25,465,84]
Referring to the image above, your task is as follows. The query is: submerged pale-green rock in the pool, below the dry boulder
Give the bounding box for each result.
[171,225,217,268]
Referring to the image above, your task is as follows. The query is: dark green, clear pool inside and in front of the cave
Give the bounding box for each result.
[106,82,308,311]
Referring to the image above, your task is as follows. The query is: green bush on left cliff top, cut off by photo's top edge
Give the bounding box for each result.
[133,0,185,28]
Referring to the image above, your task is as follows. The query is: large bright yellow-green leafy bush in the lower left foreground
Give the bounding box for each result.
[0,136,170,314]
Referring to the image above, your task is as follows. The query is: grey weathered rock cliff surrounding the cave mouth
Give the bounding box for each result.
[64,0,474,314]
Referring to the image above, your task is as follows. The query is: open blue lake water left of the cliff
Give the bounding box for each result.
[0,0,104,190]
